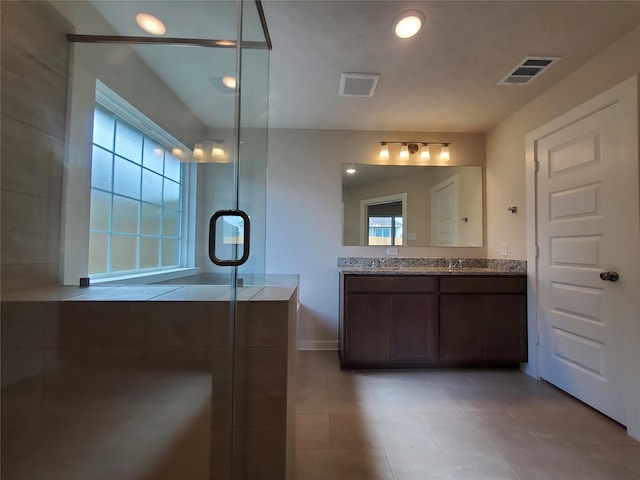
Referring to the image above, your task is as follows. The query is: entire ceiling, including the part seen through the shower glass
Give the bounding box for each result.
[53,0,640,133]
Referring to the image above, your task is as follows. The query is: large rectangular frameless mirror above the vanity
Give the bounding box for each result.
[342,164,483,247]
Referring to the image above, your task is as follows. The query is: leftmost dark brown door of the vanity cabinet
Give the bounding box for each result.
[345,293,391,364]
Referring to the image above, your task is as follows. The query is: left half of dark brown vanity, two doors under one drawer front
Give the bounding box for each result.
[340,275,438,368]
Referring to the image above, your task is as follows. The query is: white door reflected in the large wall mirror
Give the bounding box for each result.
[431,175,458,247]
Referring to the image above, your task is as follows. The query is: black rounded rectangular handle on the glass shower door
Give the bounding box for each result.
[209,210,251,267]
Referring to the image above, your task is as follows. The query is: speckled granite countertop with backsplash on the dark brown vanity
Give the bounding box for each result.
[337,257,527,276]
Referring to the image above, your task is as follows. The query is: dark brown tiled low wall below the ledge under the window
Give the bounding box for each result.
[0,292,297,480]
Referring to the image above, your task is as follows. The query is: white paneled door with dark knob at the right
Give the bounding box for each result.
[535,82,640,424]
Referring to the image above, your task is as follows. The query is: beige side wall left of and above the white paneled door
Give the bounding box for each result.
[486,23,640,260]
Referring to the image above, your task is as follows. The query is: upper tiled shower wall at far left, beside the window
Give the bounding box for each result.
[0,1,72,294]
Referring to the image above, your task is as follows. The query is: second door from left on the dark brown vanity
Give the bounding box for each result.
[391,294,438,363]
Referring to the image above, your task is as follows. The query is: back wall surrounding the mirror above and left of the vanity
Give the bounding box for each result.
[266,129,486,348]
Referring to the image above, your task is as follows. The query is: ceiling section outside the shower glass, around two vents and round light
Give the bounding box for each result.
[264,0,640,132]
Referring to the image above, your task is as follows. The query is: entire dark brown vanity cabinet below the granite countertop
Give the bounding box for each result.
[340,274,527,368]
